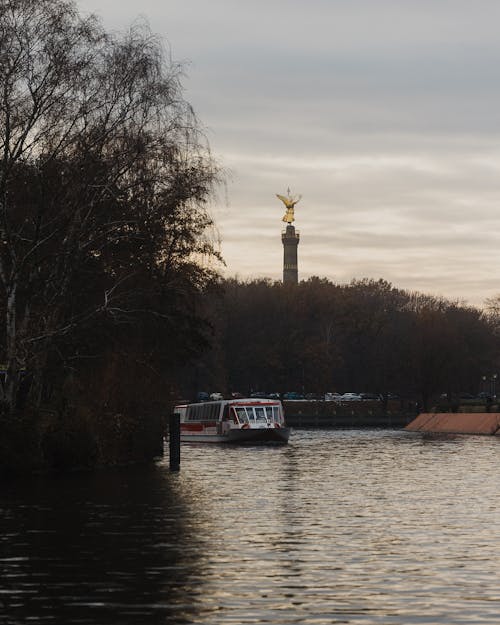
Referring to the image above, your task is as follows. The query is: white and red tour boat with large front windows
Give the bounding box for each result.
[174,397,290,445]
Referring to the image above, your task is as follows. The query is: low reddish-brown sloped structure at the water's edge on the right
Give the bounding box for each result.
[405,412,500,436]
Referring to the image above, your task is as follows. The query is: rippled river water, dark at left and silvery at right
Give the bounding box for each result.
[0,430,500,625]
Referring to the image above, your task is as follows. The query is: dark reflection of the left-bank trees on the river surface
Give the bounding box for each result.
[0,467,204,624]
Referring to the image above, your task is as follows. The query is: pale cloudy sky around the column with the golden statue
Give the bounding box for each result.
[76,0,500,306]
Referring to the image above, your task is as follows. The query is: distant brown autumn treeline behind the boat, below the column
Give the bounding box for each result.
[183,278,499,406]
